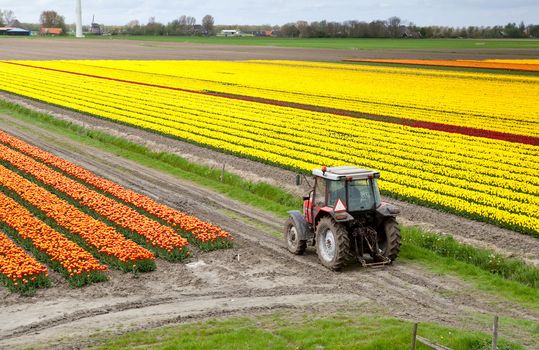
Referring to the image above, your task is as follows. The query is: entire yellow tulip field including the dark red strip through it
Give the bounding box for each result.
[0,61,539,235]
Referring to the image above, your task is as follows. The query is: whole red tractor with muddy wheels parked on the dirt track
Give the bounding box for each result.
[284,166,400,270]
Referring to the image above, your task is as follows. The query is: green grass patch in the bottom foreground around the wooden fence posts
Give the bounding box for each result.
[92,311,524,350]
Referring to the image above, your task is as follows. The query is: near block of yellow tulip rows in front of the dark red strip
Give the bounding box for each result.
[0,62,539,235]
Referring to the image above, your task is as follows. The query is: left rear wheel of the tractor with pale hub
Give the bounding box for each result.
[316,217,351,271]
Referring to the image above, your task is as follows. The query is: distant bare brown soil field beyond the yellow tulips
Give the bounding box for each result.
[0,38,539,61]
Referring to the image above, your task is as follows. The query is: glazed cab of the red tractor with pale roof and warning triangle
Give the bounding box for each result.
[303,166,381,225]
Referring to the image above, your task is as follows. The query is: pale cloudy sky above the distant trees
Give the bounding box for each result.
[0,0,539,27]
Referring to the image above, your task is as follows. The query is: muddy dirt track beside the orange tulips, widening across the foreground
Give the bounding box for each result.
[0,110,539,349]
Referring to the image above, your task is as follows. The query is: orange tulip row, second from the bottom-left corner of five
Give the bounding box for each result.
[0,188,107,286]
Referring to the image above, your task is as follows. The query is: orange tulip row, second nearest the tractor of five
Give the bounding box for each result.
[0,145,189,261]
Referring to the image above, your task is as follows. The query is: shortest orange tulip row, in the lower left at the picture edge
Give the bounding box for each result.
[0,231,50,293]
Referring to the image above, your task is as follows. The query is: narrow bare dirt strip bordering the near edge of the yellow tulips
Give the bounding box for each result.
[0,92,539,266]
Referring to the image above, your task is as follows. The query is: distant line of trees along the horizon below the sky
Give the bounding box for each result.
[0,10,539,38]
